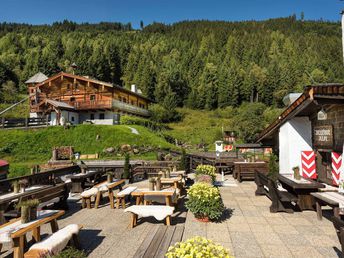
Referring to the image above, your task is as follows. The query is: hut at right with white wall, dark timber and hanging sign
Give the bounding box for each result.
[257,84,344,184]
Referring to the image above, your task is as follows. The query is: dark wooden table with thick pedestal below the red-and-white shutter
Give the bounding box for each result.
[278,174,325,211]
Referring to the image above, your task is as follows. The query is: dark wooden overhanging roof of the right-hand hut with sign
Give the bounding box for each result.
[257,83,344,142]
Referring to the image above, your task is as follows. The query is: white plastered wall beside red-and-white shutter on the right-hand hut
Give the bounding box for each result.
[279,117,312,174]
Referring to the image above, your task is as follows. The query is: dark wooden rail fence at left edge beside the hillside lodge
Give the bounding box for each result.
[0,117,49,129]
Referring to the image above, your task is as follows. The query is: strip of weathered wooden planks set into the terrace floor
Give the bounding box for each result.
[133,225,184,258]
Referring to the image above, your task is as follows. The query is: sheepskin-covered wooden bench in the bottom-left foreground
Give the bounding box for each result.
[24,224,82,258]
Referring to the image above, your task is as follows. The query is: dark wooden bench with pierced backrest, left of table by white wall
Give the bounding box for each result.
[255,172,298,213]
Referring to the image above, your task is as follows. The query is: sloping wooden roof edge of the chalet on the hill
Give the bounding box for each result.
[36,72,153,102]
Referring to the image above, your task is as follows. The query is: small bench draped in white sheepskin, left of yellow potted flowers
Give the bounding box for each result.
[124,205,174,228]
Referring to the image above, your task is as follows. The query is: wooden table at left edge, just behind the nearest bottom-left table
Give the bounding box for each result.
[0,185,53,225]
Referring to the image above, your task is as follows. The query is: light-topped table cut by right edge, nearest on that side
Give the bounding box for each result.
[311,192,344,220]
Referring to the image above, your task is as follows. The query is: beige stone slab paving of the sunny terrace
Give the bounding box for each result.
[0,176,341,258]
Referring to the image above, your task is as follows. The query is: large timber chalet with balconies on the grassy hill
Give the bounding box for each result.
[26,72,152,125]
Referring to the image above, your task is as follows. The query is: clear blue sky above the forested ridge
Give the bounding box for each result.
[0,0,344,28]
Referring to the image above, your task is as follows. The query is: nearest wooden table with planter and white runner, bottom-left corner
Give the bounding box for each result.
[0,210,65,258]
